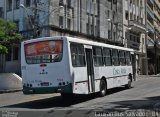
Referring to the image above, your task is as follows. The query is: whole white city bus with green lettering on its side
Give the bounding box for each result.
[21,36,134,96]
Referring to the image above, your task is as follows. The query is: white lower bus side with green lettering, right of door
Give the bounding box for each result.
[94,66,132,89]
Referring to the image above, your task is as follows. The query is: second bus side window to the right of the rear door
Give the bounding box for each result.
[103,48,112,66]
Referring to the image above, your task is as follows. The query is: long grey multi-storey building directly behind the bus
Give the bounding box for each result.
[0,0,124,74]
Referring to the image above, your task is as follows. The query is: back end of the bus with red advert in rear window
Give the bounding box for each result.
[21,39,72,94]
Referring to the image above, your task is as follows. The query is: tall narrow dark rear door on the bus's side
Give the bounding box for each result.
[85,48,95,93]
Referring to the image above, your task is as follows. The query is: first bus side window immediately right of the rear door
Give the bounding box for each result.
[93,47,103,66]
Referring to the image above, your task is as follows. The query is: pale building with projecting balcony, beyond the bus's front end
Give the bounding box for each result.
[123,0,148,74]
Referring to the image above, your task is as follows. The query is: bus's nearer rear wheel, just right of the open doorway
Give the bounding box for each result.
[99,79,107,97]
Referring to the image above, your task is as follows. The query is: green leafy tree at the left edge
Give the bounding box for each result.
[0,18,22,54]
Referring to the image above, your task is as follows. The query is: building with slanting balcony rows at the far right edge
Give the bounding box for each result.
[146,0,160,74]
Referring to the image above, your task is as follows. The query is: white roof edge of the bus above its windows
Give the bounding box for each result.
[22,36,134,51]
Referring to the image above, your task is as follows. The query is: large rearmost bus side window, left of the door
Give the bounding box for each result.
[70,43,85,67]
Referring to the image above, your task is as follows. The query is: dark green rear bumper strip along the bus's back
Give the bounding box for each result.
[23,83,72,94]
